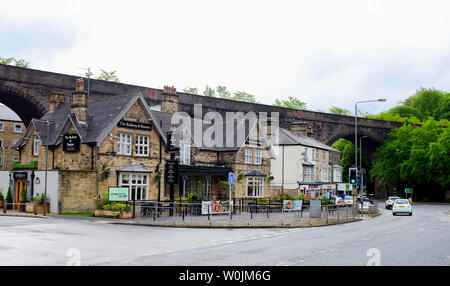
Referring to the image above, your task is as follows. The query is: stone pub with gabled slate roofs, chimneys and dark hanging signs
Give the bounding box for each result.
[0,79,273,213]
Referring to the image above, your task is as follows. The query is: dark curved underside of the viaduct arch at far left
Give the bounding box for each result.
[0,86,46,126]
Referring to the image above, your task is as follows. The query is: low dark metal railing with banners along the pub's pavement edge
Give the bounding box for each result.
[136,201,361,227]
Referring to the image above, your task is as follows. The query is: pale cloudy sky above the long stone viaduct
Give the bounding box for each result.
[0,0,450,114]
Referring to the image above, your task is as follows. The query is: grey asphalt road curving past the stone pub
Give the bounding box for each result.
[0,205,450,266]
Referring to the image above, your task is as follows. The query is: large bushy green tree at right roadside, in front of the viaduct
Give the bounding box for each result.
[370,119,450,200]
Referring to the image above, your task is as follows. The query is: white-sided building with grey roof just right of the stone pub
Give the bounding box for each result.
[271,122,342,198]
